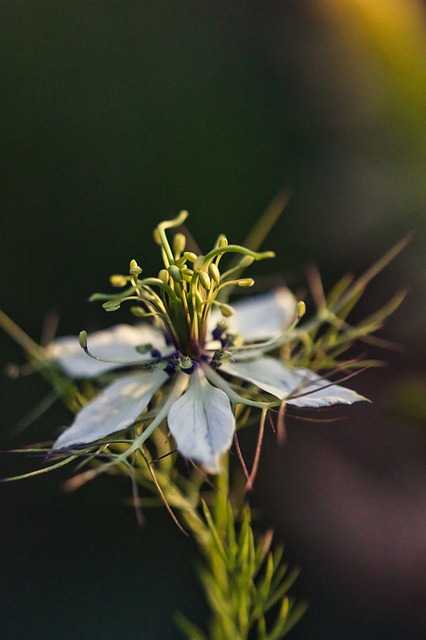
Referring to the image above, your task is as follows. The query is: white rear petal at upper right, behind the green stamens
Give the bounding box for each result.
[209,287,296,342]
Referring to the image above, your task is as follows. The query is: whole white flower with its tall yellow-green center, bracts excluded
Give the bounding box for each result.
[48,212,364,473]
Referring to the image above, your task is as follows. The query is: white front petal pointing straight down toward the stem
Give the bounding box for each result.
[168,369,235,473]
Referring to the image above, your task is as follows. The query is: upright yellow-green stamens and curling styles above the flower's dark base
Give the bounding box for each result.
[91,211,274,358]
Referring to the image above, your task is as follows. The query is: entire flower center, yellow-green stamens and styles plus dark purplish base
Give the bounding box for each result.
[91,211,274,372]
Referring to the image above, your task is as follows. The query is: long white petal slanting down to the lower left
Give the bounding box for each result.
[52,370,169,450]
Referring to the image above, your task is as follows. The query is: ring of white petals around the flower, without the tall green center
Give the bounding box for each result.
[49,288,364,472]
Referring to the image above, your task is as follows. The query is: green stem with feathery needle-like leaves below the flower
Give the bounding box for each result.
[149,455,305,640]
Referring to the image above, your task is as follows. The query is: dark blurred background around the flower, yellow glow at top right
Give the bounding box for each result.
[0,0,426,640]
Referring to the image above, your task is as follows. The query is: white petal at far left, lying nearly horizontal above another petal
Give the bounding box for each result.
[47,324,173,378]
